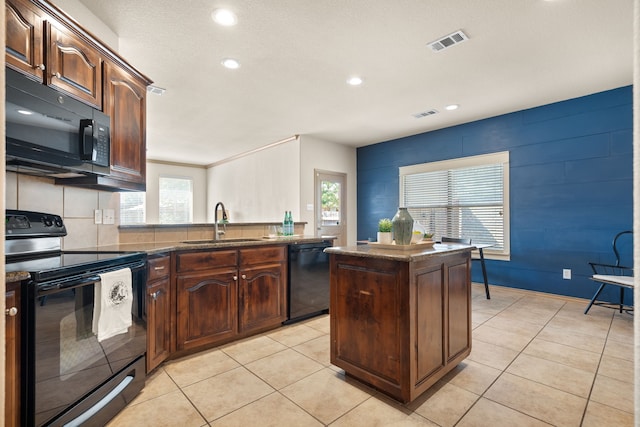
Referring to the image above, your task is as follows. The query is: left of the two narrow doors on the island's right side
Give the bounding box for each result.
[413,264,446,385]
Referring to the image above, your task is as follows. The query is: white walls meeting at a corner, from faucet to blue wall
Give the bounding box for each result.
[207,135,357,245]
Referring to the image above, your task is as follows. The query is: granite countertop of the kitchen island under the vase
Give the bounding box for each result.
[324,242,475,262]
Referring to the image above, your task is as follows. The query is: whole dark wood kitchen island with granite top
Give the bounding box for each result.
[325,243,474,403]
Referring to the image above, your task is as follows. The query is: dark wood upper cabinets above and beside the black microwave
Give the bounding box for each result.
[5,0,152,191]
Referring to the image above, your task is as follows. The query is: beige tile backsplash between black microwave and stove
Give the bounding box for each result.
[5,172,120,250]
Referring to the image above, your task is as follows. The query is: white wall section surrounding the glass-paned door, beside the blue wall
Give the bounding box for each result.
[300,135,358,245]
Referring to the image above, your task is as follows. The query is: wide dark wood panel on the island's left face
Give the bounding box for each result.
[329,257,408,390]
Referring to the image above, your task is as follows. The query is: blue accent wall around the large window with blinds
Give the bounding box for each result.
[357,86,633,301]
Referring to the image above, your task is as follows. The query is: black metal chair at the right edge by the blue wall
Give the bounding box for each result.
[584,230,633,314]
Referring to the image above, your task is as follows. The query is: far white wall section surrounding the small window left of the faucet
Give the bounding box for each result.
[145,160,207,224]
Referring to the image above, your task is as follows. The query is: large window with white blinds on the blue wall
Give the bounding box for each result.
[400,152,509,259]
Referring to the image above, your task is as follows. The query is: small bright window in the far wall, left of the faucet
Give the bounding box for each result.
[158,176,193,224]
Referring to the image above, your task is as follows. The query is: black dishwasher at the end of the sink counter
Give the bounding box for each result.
[283,240,333,325]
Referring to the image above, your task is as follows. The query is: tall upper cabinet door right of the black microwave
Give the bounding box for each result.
[104,62,147,187]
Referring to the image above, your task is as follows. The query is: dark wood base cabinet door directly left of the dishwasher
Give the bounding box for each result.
[238,263,287,333]
